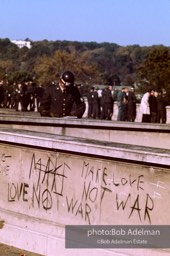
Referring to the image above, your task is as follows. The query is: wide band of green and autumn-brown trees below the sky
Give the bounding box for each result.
[0,38,170,100]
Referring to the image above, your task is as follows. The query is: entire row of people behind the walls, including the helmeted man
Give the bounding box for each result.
[0,71,166,123]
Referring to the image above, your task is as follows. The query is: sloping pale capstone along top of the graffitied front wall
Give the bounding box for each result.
[0,129,170,166]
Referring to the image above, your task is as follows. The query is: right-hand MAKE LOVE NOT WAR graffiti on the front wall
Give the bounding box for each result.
[66,162,154,223]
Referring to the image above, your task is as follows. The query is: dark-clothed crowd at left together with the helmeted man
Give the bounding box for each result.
[0,71,85,118]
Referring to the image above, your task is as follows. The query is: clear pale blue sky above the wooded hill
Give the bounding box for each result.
[0,0,170,46]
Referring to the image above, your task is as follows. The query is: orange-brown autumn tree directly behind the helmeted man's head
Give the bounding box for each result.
[34,50,97,84]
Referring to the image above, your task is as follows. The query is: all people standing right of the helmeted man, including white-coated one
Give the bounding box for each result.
[87,86,166,123]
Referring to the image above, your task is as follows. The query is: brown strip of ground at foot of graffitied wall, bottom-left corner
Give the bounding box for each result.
[0,244,42,256]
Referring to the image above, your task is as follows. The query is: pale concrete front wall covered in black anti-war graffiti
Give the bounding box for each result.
[0,130,170,256]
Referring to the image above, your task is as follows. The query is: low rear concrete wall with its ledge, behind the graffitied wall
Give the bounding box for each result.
[0,115,170,149]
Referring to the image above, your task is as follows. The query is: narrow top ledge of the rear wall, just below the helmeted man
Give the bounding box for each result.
[0,112,170,132]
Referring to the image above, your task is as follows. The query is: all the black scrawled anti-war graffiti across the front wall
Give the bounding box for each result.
[0,153,165,224]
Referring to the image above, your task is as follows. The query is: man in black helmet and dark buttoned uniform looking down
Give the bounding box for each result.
[40,71,85,118]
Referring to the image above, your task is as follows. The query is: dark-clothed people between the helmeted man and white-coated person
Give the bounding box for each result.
[87,86,137,122]
